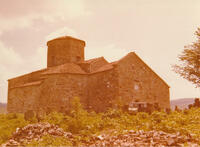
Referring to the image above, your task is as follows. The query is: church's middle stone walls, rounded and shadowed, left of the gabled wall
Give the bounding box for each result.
[37,70,118,112]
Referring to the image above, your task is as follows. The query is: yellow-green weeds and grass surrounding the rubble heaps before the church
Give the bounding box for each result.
[0,99,200,146]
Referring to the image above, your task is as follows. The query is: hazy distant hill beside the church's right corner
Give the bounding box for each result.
[170,98,194,109]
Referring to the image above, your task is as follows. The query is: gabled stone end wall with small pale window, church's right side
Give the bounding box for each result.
[117,53,170,108]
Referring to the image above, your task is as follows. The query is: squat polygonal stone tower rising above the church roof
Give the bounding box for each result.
[47,36,85,67]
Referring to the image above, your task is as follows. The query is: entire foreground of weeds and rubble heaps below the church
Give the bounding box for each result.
[0,106,200,147]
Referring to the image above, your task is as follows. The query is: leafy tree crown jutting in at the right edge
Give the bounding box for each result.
[173,28,200,87]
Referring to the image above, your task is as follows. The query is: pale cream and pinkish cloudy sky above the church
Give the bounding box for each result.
[0,0,200,102]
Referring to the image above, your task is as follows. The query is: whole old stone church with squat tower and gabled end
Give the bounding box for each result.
[7,36,170,112]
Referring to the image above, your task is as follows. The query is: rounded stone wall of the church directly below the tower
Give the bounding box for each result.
[37,74,87,111]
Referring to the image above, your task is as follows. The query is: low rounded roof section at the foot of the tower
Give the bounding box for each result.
[42,63,86,74]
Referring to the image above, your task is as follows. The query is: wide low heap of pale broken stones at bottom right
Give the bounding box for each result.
[89,130,199,147]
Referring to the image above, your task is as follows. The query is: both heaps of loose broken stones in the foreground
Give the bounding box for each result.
[2,123,198,147]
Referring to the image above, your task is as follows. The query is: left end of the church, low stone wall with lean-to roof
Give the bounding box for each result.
[7,69,45,112]
